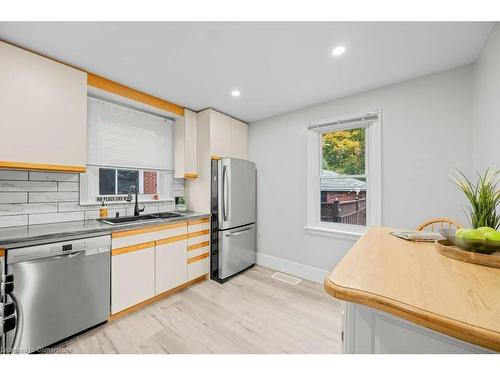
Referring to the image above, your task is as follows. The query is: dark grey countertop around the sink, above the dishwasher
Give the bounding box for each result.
[0,211,209,250]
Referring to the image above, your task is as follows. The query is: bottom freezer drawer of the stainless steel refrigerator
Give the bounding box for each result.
[219,224,256,279]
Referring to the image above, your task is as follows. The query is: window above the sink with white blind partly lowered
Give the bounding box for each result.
[80,97,174,204]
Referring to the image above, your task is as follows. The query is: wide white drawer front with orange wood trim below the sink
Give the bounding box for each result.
[111,221,187,249]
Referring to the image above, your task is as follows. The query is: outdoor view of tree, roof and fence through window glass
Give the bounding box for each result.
[320,127,366,225]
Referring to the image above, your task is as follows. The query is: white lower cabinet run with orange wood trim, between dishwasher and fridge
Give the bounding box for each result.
[111,218,210,316]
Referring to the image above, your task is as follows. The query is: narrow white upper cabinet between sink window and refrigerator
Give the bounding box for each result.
[174,109,198,178]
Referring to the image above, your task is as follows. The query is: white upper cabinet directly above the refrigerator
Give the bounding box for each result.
[210,110,248,159]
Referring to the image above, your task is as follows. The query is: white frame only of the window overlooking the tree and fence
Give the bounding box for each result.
[305,110,382,237]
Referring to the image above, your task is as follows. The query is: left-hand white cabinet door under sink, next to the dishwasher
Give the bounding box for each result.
[111,244,155,314]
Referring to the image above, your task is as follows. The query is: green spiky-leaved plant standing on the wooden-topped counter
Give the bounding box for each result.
[452,169,500,229]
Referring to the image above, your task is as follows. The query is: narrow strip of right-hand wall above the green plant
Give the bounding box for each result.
[474,24,500,171]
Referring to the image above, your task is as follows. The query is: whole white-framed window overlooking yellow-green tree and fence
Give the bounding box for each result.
[306,111,381,234]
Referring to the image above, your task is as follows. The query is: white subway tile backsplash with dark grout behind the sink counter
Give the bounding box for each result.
[0,170,184,227]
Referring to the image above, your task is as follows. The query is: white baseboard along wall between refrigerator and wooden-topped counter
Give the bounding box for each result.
[257,253,329,284]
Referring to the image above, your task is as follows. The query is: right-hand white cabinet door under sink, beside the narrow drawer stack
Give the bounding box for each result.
[155,239,187,294]
